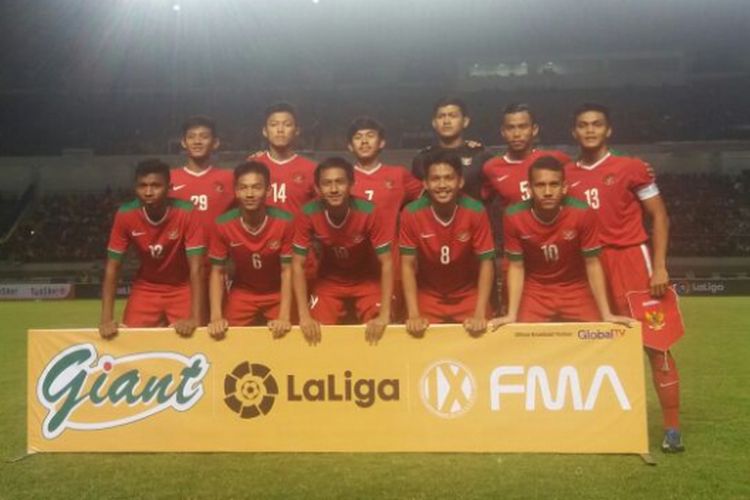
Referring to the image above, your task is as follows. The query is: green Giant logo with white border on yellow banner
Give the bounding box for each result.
[36,344,209,439]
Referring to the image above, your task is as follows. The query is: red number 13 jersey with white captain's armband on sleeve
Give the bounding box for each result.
[565,152,659,247]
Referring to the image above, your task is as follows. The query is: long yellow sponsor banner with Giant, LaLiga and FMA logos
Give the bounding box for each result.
[28,323,648,453]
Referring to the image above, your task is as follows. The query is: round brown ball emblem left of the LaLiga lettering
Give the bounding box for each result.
[224,361,279,418]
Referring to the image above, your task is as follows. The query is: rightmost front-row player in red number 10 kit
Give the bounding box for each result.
[491,156,633,328]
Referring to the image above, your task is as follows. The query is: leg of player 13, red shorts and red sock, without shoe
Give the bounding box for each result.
[602,245,684,451]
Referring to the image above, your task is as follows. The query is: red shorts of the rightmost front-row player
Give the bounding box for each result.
[518,281,602,323]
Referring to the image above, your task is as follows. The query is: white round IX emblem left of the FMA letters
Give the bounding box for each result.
[419,360,477,418]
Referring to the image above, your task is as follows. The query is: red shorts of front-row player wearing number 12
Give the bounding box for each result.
[122,282,191,328]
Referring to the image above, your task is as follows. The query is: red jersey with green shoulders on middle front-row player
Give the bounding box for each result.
[293,198,395,285]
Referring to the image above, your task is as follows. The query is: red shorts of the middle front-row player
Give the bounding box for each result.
[310,280,381,325]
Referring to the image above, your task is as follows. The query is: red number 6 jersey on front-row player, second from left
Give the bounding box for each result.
[208,207,294,294]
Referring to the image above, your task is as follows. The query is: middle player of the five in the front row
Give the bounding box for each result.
[292,158,395,344]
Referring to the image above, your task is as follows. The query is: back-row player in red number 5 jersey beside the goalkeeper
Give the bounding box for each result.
[482,103,570,208]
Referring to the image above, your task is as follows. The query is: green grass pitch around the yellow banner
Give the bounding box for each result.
[0,298,750,499]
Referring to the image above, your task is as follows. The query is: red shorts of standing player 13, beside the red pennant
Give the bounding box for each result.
[599,244,652,316]
